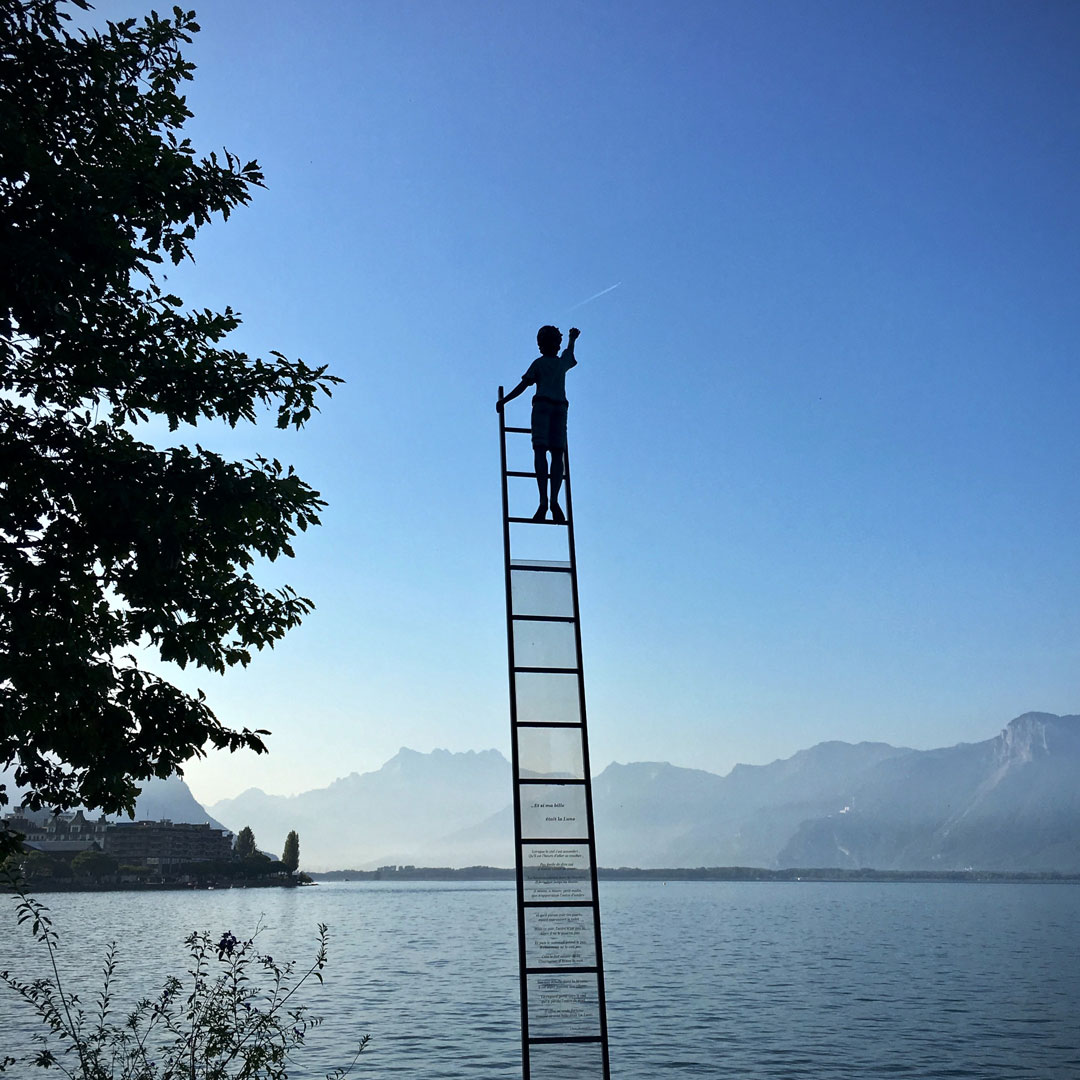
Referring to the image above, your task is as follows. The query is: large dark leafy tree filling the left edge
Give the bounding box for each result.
[0,0,339,854]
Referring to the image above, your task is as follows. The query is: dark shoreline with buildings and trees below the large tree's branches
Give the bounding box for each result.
[2,810,311,891]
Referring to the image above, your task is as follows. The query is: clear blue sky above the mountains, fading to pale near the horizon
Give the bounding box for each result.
[82,0,1080,801]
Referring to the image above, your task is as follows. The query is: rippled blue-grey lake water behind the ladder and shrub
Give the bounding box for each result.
[0,882,1080,1080]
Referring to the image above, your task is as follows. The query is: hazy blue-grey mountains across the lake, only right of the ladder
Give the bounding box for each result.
[594,713,1080,870]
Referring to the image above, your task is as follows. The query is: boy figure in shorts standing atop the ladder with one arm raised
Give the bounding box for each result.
[495,326,581,522]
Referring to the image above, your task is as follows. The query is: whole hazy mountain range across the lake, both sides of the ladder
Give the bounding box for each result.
[204,713,1080,873]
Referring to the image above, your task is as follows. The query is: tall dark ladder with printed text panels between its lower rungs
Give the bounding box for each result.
[499,387,610,1080]
